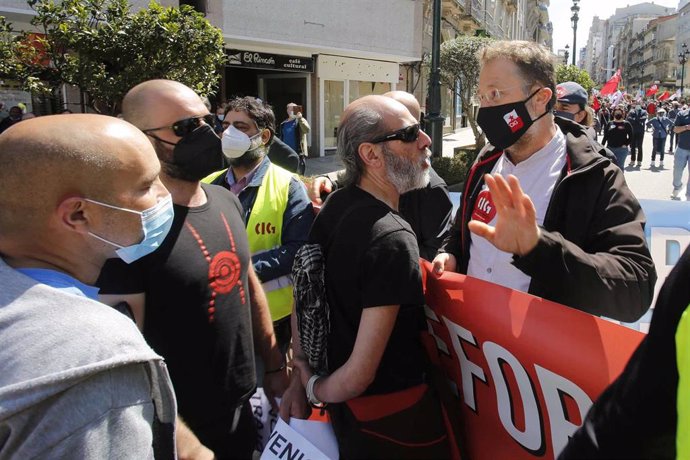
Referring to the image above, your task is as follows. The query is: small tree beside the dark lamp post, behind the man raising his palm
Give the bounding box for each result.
[440,35,492,151]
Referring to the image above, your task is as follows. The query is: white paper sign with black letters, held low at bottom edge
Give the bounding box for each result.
[261,418,338,460]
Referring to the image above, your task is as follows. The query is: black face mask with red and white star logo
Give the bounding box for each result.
[477,88,549,150]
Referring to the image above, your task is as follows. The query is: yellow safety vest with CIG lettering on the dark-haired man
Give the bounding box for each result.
[247,164,293,322]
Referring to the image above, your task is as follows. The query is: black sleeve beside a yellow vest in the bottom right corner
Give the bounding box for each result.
[558,249,690,460]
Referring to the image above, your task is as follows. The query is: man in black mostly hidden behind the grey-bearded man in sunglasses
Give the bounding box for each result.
[309,91,453,260]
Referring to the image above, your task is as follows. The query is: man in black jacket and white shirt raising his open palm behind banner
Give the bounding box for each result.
[434,41,656,321]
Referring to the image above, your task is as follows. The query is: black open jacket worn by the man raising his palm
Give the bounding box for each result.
[441,117,656,322]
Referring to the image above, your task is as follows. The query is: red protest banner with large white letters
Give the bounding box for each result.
[423,262,643,460]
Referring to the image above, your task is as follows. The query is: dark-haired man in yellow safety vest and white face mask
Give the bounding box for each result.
[204,96,314,352]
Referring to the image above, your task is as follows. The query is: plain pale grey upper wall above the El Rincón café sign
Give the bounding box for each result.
[216,0,422,61]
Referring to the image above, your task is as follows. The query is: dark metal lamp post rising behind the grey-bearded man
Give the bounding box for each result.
[427,0,445,157]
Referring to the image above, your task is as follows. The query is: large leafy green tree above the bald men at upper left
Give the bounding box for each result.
[4,0,225,115]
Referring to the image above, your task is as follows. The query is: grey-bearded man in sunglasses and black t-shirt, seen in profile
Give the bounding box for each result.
[281,96,448,458]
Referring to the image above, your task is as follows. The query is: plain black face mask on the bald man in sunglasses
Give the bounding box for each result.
[163,124,223,182]
